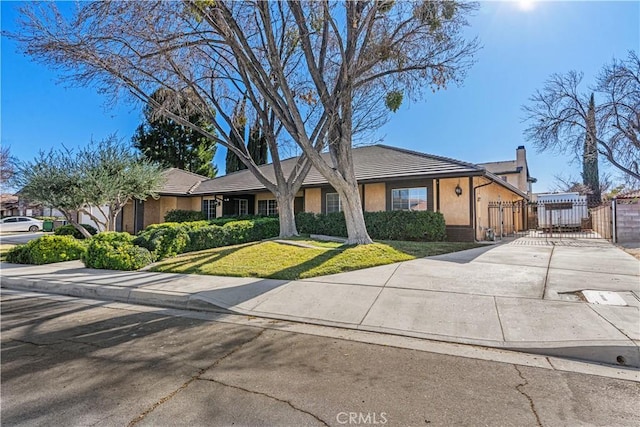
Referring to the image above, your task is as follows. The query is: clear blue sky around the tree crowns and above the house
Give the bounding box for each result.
[0,1,640,192]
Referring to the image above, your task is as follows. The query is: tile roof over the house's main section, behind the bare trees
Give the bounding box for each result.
[192,144,484,194]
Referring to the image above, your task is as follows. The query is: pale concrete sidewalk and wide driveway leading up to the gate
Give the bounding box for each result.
[1,238,640,367]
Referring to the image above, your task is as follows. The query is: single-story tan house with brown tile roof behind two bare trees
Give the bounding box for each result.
[122,145,528,241]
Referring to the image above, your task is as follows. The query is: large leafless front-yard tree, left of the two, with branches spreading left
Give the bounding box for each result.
[10,1,322,237]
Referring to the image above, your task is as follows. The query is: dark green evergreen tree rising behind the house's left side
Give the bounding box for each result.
[132,91,218,178]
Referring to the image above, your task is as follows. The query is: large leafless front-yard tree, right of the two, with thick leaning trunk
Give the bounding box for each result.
[187,0,477,243]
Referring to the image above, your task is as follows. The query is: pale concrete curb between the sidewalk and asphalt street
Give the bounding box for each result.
[0,277,640,368]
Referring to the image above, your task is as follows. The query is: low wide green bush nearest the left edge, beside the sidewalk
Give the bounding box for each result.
[6,236,85,265]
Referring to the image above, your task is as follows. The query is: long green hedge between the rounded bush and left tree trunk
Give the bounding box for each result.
[134,218,280,260]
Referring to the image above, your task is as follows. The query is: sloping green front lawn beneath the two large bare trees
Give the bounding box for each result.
[151,239,479,280]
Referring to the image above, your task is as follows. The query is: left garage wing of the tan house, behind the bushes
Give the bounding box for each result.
[116,168,213,234]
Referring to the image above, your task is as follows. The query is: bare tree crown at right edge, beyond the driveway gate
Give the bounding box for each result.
[523,53,640,179]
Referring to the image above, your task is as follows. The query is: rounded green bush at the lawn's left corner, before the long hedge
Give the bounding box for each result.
[82,231,152,271]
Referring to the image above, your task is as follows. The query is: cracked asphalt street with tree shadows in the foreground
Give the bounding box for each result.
[1,290,640,426]
